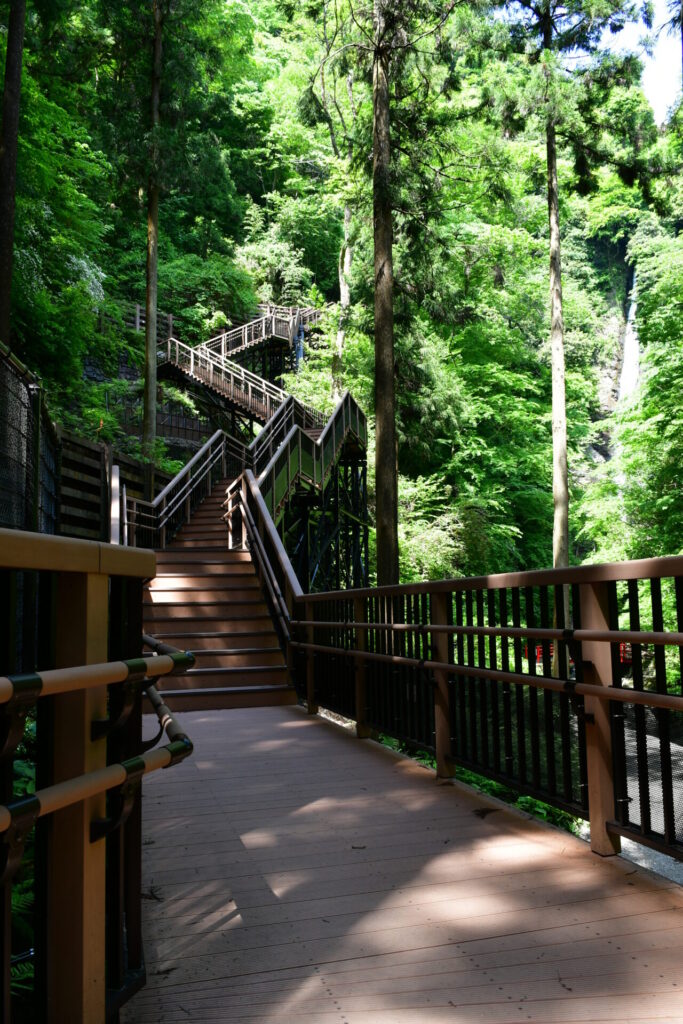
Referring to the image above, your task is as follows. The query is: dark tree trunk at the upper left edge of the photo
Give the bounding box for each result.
[0,0,26,345]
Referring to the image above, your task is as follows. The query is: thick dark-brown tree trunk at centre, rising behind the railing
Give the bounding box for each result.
[373,0,398,587]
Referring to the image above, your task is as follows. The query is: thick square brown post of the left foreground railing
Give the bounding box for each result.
[46,572,109,1024]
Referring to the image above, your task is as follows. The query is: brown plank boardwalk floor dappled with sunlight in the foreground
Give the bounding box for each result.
[122,707,683,1024]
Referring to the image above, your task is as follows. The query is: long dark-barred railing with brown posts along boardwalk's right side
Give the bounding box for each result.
[292,558,683,856]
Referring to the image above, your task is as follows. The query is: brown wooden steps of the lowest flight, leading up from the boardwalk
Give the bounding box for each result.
[144,480,296,711]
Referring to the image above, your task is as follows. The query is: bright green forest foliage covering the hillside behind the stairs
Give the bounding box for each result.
[0,0,683,580]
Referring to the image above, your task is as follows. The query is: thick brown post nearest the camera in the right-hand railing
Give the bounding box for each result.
[579,583,622,857]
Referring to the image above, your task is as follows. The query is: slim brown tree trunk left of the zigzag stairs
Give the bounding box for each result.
[142,0,163,459]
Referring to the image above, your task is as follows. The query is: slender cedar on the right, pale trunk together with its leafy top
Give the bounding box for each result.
[509,0,636,567]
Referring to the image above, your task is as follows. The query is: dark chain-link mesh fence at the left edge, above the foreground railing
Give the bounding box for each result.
[0,349,58,534]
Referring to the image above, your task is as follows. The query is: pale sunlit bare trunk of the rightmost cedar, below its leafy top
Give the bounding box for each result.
[546,118,569,568]
